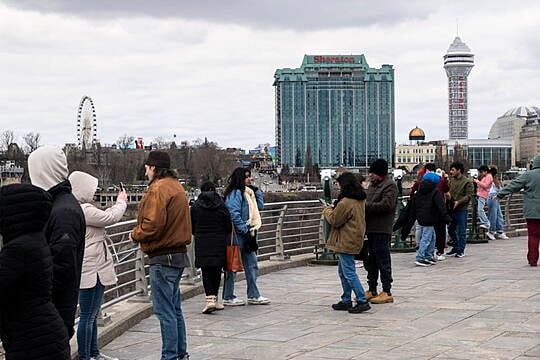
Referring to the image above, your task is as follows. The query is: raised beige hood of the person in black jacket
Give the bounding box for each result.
[28,145,68,190]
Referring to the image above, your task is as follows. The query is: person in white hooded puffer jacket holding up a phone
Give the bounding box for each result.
[69,171,127,360]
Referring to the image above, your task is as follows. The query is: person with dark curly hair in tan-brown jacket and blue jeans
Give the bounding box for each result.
[323,172,371,313]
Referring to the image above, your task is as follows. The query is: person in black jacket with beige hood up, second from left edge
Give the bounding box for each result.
[28,146,86,338]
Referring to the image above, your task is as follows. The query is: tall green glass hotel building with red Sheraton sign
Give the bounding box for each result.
[274,55,395,167]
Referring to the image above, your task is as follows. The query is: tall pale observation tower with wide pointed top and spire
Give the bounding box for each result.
[444,36,474,140]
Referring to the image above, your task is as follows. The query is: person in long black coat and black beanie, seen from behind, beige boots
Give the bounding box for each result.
[191,182,232,314]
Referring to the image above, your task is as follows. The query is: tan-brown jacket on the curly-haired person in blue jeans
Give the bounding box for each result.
[323,198,366,254]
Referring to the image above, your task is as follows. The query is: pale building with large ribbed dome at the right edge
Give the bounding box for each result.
[488,106,540,166]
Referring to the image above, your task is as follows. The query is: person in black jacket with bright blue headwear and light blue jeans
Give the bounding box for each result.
[411,172,452,266]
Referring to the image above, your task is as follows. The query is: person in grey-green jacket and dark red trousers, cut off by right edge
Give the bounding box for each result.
[497,155,540,266]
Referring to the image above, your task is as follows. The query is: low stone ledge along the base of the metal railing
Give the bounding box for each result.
[71,253,314,360]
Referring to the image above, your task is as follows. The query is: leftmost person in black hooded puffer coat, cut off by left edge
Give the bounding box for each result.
[0,184,70,360]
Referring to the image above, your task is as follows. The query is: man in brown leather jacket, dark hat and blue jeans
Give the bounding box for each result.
[130,151,191,360]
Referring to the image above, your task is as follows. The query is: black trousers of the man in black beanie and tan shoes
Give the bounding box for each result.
[364,233,393,294]
